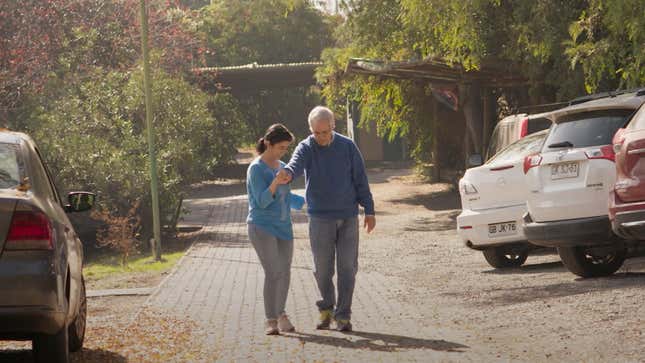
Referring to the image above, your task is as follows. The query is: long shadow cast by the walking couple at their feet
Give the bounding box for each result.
[285,331,469,353]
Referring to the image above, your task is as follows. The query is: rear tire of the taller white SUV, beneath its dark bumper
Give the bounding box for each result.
[558,245,627,277]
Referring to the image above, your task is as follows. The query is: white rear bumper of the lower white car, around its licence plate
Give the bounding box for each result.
[457,204,526,250]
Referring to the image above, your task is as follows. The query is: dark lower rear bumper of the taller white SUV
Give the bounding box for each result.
[523,213,616,247]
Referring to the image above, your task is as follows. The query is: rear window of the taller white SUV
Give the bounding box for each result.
[543,109,634,151]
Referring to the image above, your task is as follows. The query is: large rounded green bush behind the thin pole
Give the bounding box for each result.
[29,70,244,222]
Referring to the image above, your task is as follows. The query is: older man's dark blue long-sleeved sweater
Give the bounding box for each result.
[285,132,374,219]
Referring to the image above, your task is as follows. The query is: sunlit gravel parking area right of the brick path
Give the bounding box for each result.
[360,169,645,362]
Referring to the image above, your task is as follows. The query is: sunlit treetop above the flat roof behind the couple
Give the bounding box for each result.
[201,0,332,66]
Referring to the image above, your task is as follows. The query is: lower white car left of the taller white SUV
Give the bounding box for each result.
[457,130,550,268]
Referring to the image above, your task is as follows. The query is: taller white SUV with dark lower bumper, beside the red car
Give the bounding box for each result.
[523,92,645,277]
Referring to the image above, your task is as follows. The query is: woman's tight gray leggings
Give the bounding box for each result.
[249,223,293,319]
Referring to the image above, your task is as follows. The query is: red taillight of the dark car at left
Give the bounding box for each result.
[4,211,54,250]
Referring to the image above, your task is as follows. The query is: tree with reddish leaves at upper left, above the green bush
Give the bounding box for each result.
[0,0,205,128]
